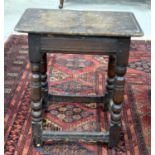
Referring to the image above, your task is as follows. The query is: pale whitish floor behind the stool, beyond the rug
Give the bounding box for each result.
[4,0,151,40]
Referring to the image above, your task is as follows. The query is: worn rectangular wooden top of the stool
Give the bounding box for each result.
[15,9,143,37]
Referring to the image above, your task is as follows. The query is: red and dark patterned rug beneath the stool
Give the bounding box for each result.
[4,35,151,155]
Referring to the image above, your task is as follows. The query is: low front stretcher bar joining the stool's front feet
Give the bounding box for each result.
[42,130,109,143]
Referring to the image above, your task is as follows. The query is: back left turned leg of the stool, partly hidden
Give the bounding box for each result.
[40,53,48,108]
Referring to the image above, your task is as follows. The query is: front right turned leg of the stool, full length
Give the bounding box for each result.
[109,38,130,147]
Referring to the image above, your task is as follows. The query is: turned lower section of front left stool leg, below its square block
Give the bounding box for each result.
[31,62,42,147]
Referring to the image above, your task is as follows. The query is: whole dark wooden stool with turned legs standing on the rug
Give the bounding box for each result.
[15,9,143,147]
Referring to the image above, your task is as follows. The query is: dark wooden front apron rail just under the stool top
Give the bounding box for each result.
[41,35,119,55]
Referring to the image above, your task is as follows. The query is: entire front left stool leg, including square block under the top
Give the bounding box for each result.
[28,34,42,147]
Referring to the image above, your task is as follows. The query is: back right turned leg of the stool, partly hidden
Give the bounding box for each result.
[104,55,116,111]
